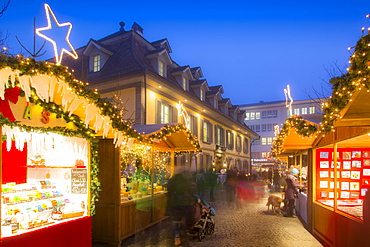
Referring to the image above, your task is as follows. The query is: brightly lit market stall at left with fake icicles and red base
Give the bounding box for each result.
[0,55,136,247]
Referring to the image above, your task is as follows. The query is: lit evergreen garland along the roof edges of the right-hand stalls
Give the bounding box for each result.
[270,34,370,157]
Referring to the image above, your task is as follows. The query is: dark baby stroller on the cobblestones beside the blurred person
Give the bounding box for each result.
[188,195,216,241]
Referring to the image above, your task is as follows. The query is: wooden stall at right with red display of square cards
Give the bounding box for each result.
[272,34,370,246]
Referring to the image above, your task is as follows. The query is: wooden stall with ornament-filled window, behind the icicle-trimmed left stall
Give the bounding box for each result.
[93,124,200,246]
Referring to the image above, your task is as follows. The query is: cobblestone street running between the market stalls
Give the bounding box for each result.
[111,187,322,247]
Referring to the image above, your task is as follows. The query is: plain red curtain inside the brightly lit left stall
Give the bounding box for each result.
[2,141,27,184]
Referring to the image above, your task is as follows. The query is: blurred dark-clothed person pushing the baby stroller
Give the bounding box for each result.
[167,167,197,246]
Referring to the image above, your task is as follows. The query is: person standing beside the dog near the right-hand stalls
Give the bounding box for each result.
[284,168,299,217]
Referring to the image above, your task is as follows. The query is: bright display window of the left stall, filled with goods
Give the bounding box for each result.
[1,126,90,237]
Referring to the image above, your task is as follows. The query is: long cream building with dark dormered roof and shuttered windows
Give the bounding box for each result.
[64,22,258,172]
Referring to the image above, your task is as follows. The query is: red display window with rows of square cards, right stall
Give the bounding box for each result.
[316,148,370,219]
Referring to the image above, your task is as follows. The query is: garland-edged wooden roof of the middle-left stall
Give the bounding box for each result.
[132,123,200,152]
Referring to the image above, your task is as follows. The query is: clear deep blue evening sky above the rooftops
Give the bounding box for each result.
[0,0,370,105]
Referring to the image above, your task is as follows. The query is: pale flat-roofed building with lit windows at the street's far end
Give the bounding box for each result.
[240,99,323,172]
